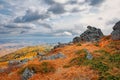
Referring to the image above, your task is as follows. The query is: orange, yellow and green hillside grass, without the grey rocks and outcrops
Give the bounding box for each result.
[0,36,120,80]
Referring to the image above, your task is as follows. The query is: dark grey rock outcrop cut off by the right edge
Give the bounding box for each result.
[111,21,120,40]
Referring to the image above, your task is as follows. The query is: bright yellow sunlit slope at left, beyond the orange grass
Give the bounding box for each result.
[0,46,51,62]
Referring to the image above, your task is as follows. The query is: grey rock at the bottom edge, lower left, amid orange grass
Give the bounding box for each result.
[22,68,34,80]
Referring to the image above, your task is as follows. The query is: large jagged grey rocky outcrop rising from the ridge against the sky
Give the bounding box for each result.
[73,26,103,43]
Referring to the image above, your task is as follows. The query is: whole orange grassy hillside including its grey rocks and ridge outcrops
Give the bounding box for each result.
[0,22,120,80]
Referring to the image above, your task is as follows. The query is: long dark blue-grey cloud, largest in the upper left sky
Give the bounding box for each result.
[14,9,49,23]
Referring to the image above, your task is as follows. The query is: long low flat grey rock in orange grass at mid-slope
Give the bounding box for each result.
[40,53,66,61]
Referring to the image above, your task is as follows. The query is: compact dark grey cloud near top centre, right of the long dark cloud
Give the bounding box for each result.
[48,3,66,14]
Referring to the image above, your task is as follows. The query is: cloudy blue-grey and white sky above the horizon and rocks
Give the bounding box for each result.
[0,0,120,37]
